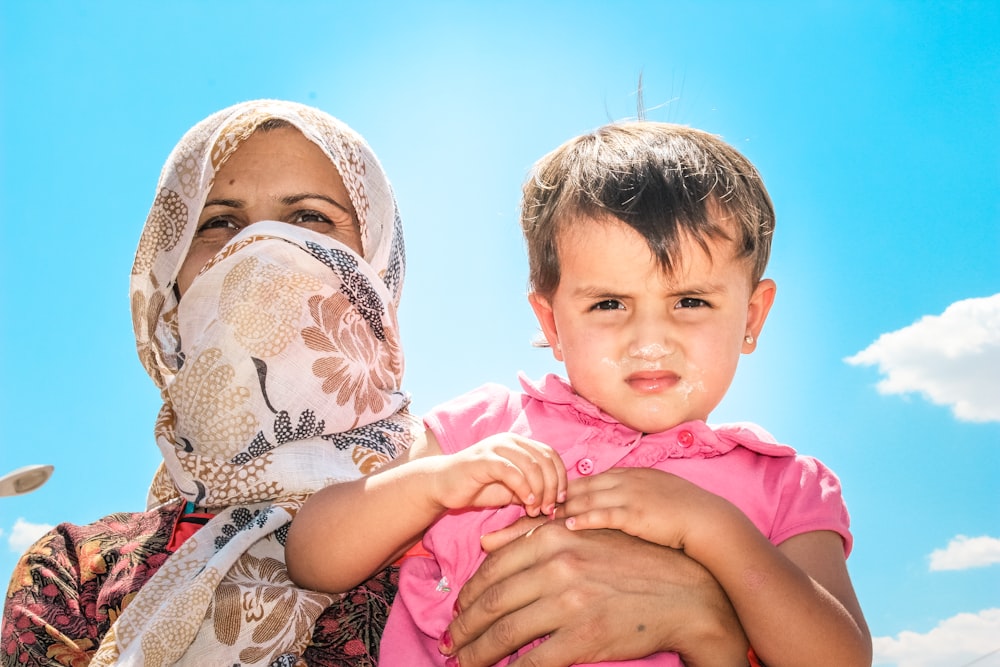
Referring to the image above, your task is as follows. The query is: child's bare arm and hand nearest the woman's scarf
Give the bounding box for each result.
[285,431,566,593]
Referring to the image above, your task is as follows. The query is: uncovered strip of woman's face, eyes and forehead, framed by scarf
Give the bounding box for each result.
[177,127,364,295]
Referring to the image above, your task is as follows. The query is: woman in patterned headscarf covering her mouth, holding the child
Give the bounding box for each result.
[2,101,745,667]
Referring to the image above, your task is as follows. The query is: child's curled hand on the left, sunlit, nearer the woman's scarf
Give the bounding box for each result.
[432,433,566,516]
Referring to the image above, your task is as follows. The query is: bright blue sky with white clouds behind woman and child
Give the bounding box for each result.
[0,0,1000,667]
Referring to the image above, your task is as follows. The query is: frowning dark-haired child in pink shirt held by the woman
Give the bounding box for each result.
[287,122,871,667]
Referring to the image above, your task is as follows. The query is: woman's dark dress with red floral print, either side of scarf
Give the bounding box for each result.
[0,502,398,667]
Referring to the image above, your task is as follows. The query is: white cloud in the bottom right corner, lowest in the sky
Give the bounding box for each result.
[873,609,1000,667]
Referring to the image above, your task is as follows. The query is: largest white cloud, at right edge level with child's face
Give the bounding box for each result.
[844,294,1000,422]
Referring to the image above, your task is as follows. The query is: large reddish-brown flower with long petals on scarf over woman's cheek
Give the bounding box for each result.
[302,292,403,415]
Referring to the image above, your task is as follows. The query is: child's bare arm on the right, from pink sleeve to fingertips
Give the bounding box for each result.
[560,468,872,667]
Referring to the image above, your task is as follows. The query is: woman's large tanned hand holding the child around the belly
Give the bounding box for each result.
[449,521,747,667]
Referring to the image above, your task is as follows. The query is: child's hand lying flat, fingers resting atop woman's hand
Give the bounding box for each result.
[558,468,725,549]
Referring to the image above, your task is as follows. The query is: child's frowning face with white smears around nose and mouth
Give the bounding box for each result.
[530,218,775,433]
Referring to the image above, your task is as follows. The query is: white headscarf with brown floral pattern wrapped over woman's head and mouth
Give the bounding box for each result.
[91,100,419,666]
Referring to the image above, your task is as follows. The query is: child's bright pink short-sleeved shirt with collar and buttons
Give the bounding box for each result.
[379,375,852,667]
